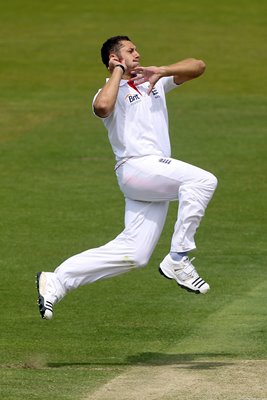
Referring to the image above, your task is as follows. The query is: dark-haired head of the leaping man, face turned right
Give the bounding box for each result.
[101,36,140,68]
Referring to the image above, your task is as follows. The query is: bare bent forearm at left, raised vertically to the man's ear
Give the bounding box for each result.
[93,63,123,118]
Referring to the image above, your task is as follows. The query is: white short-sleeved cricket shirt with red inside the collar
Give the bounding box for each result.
[93,77,178,161]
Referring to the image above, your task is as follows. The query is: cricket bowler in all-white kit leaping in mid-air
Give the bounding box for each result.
[37,36,217,319]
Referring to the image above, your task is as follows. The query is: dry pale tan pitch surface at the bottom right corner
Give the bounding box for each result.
[84,360,267,400]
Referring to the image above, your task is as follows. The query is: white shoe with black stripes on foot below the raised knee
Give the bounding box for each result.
[159,254,210,294]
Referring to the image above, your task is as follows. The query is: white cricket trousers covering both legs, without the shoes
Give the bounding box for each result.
[55,155,217,293]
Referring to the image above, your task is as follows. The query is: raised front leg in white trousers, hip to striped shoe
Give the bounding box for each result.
[118,156,217,293]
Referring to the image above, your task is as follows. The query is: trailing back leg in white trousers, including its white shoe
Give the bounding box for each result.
[37,199,168,319]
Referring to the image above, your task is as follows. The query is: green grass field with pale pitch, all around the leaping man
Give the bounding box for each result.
[0,0,267,400]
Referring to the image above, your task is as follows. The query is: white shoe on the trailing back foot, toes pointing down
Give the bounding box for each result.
[36,272,64,319]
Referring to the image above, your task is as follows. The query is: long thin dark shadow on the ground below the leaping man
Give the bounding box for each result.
[47,352,233,369]
